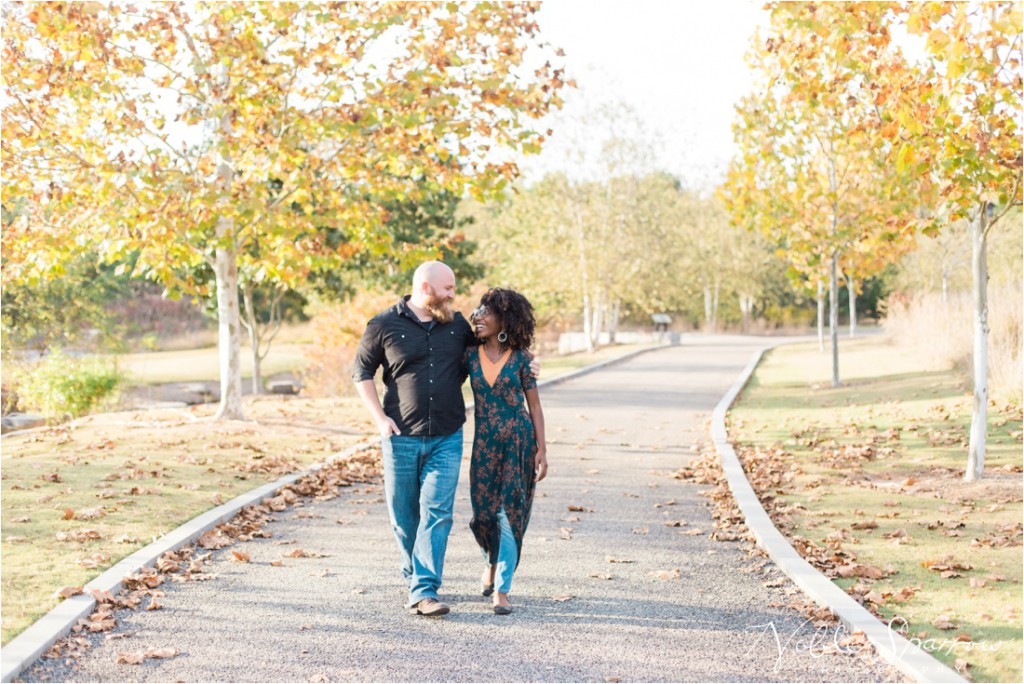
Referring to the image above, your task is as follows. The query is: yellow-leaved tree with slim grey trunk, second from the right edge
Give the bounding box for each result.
[725,3,913,386]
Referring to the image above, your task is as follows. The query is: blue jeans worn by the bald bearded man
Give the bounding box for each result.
[383,428,462,606]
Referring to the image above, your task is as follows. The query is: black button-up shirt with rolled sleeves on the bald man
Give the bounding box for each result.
[352,295,477,436]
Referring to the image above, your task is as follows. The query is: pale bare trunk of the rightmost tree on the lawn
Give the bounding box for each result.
[964,202,988,482]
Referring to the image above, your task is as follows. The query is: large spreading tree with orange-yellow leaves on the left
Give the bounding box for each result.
[3,2,566,418]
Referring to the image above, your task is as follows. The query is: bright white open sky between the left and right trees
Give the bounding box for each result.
[521,0,767,186]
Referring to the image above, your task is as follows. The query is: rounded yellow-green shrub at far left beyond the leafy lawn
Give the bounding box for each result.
[17,350,124,423]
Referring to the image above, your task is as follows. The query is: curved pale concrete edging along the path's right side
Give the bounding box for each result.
[712,342,968,682]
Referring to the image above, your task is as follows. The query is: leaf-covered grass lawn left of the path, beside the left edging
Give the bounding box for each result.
[0,396,372,644]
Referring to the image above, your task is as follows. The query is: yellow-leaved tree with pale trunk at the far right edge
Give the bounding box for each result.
[889,2,1024,481]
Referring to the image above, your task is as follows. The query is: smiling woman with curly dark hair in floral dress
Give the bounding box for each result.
[466,288,548,615]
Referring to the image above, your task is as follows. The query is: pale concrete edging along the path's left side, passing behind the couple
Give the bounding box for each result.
[0,344,667,682]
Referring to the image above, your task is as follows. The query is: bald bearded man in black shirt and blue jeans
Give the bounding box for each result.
[352,261,539,616]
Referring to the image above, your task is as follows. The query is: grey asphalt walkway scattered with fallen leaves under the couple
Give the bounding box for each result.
[25,336,901,682]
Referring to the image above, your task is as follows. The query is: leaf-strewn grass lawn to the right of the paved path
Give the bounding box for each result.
[729,338,1022,682]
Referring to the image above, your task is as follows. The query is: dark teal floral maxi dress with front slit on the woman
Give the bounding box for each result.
[466,347,537,566]
